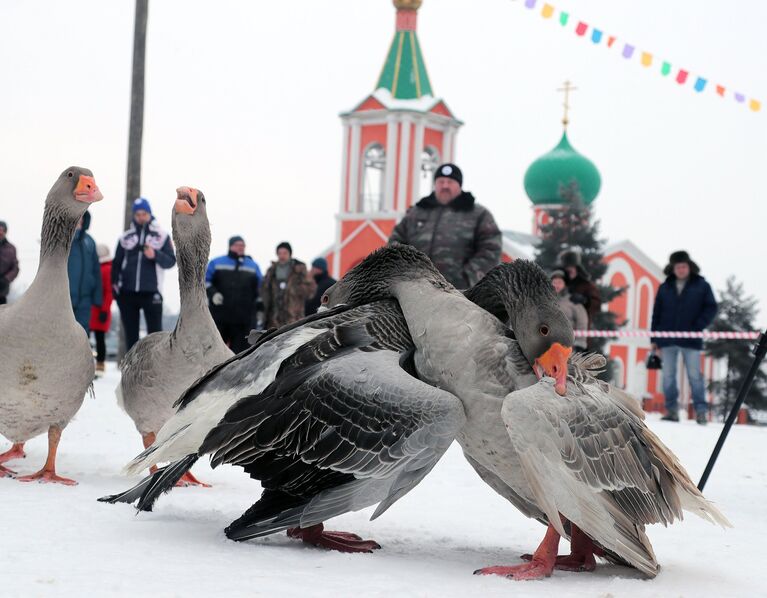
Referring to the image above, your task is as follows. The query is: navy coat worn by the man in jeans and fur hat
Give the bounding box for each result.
[651,273,717,350]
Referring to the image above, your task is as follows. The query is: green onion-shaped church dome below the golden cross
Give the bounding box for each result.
[525,131,602,205]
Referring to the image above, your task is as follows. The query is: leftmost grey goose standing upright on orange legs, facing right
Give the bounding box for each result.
[0,166,103,485]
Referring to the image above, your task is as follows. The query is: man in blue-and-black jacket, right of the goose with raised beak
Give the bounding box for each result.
[205,235,261,353]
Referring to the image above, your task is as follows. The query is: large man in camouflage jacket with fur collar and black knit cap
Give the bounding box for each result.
[389,164,502,289]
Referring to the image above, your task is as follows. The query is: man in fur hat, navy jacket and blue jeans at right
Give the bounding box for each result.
[652,251,717,424]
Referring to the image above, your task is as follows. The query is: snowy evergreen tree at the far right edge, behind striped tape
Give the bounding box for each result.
[706,276,767,415]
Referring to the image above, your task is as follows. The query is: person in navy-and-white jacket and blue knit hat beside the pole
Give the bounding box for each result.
[112,197,176,352]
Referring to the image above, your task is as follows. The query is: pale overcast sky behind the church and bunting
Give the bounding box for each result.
[0,0,767,325]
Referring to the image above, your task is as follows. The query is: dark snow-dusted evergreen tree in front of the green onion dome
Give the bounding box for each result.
[535,180,626,378]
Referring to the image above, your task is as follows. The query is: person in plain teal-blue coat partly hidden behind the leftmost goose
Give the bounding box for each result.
[67,212,102,335]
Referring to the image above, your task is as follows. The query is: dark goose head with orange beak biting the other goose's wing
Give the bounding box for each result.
[466,260,574,395]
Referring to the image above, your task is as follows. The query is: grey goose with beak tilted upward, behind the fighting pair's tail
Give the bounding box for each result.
[117,187,233,486]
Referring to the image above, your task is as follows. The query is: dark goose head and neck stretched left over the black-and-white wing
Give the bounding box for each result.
[321,243,453,308]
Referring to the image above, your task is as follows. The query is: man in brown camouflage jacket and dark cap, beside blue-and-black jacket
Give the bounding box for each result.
[261,241,317,328]
